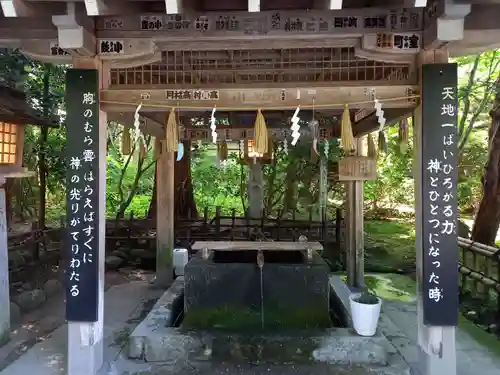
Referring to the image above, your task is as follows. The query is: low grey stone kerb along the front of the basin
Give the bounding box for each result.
[129,327,389,366]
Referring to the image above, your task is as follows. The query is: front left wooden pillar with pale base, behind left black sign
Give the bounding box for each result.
[67,58,109,375]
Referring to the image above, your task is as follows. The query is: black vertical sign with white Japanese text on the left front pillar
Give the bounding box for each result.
[65,69,101,322]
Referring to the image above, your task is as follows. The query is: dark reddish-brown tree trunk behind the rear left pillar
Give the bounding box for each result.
[148,141,198,218]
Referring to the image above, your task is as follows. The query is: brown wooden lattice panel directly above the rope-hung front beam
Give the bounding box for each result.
[111,47,415,86]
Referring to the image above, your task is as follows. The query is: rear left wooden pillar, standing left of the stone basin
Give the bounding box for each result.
[155,145,175,288]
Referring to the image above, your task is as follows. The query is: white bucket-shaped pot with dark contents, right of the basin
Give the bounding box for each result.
[349,287,382,336]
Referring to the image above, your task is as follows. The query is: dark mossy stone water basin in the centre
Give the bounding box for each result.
[181,250,345,332]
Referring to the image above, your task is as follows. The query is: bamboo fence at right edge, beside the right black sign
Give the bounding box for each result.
[458,237,500,334]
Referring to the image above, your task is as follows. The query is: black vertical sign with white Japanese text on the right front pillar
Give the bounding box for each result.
[421,64,458,326]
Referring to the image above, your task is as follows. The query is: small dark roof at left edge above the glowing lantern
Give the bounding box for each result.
[0,84,57,127]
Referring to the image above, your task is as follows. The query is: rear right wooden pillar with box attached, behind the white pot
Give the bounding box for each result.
[345,138,365,288]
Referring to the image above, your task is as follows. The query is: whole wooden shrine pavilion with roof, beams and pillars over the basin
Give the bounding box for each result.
[0,0,500,375]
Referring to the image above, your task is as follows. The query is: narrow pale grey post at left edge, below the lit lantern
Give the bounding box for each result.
[0,177,10,346]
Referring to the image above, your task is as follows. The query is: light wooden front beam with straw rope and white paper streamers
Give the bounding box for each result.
[101,82,415,116]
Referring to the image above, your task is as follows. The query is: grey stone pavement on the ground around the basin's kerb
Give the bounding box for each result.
[0,282,500,375]
